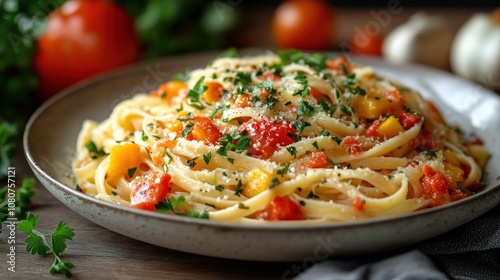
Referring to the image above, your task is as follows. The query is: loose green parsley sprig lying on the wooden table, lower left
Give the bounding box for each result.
[18,213,75,278]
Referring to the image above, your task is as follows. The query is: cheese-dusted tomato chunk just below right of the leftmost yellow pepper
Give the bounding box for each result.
[130,172,172,211]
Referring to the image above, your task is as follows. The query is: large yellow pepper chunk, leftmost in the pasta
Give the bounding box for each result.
[106,142,142,185]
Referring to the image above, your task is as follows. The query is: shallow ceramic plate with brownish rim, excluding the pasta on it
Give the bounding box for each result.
[24,53,500,261]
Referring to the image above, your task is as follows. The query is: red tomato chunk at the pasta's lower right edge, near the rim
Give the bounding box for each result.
[420,165,451,207]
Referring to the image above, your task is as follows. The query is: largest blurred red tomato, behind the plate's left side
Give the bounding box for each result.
[34,0,140,99]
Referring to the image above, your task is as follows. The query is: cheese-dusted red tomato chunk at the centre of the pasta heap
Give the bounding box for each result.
[238,118,297,159]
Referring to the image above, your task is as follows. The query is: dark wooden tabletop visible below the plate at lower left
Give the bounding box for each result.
[0,150,302,280]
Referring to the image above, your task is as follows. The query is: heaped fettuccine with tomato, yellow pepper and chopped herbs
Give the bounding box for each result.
[73,51,488,223]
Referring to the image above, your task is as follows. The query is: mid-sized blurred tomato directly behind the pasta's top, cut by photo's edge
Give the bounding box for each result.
[272,0,334,50]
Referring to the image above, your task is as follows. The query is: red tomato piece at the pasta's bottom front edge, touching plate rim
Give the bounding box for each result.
[261,196,304,221]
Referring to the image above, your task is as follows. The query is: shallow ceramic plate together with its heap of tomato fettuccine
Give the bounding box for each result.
[24,50,500,261]
